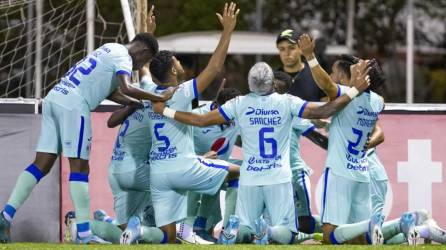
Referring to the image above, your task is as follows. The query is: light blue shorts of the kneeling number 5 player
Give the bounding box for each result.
[150,158,229,227]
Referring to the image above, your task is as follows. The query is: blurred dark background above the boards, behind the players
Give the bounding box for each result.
[0,0,446,103]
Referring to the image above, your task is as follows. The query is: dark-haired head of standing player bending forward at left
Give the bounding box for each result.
[130,33,158,70]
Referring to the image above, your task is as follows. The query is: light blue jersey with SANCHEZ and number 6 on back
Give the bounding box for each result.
[219,93,307,186]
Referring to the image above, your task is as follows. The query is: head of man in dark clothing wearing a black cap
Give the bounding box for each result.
[276,29,302,67]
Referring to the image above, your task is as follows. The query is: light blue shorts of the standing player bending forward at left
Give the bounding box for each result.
[36,100,92,160]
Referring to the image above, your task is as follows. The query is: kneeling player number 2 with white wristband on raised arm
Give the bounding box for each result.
[298,34,390,244]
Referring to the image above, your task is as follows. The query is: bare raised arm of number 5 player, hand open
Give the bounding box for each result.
[196,3,240,93]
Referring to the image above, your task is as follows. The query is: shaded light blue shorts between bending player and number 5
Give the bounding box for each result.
[108,163,155,226]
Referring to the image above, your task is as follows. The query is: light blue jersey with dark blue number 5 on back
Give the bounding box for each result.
[149,79,198,173]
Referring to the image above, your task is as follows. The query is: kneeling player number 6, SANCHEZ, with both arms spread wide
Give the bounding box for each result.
[152,61,369,244]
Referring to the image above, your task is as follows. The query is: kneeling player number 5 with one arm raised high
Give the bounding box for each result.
[120,3,239,243]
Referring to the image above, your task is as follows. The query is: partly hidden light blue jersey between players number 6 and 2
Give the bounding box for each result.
[290,117,315,171]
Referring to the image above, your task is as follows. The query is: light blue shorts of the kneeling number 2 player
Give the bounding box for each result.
[322,168,372,226]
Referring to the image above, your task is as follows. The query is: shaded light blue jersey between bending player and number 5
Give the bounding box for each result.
[110,83,156,172]
